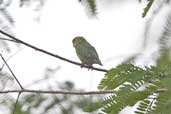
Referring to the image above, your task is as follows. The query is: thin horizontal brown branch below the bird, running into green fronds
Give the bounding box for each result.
[0,89,115,95]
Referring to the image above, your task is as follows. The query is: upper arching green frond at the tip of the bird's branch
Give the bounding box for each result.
[98,64,154,90]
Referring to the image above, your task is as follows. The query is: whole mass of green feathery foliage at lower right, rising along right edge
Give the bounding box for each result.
[85,8,171,114]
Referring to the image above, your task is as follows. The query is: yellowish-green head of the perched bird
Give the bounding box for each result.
[72,36,87,47]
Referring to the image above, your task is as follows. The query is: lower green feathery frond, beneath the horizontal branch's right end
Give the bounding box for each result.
[86,84,157,114]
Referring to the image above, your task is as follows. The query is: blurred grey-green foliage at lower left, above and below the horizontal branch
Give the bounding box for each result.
[0,67,97,114]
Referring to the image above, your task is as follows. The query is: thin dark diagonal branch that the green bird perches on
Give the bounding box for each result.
[0,30,108,72]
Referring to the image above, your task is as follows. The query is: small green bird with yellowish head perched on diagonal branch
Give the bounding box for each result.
[72,36,102,68]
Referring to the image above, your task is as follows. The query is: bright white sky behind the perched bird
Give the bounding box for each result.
[1,0,168,111]
